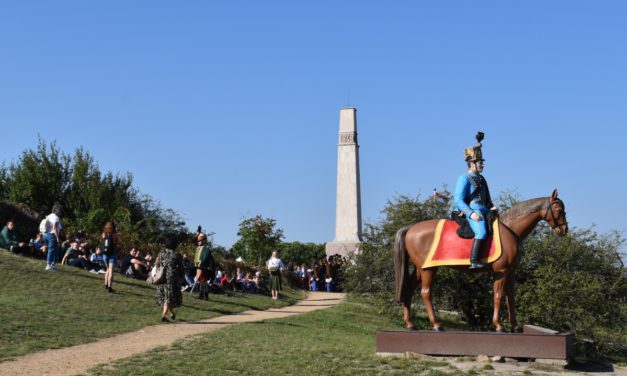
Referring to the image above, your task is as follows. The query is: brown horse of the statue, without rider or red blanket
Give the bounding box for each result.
[394,190,568,332]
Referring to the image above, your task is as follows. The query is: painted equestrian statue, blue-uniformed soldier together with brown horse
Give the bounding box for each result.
[394,132,568,332]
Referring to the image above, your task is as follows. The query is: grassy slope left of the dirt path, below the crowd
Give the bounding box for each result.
[0,250,305,361]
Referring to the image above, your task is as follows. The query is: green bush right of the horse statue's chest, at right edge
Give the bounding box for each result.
[516,229,627,359]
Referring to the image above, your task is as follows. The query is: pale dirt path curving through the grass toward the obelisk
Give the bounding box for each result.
[0,292,345,376]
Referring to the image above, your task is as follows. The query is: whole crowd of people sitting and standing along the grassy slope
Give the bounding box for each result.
[0,204,342,322]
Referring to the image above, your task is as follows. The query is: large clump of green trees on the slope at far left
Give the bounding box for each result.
[0,139,188,250]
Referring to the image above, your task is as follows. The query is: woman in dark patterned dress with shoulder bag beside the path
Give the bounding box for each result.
[155,237,185,322]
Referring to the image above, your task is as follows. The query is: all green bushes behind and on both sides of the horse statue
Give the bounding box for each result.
[345,192,627,361]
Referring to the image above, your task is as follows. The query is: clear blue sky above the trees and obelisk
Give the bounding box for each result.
[0,1,627,246]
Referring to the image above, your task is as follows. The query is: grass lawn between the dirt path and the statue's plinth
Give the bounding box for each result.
[89,301,474,375]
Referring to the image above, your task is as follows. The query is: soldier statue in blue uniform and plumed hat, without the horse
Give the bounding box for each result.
[454,132,496,269]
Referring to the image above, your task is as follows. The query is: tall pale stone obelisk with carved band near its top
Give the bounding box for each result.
[326,108,361,256]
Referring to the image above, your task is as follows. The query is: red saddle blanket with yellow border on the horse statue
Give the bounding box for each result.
[422,219,501,269]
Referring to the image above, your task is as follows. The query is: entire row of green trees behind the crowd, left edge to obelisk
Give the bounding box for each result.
[0,139,325,265]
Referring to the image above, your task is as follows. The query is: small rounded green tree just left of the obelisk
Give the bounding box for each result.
[233,215,283,265]
